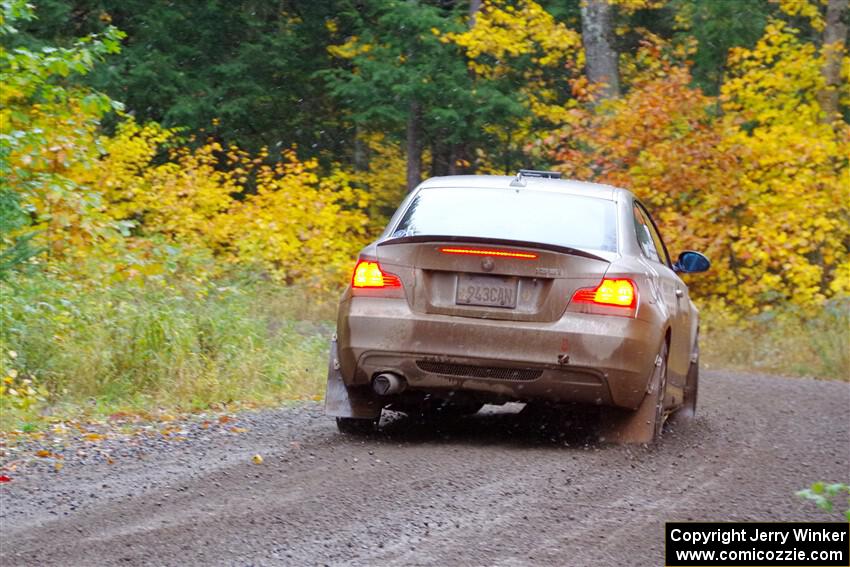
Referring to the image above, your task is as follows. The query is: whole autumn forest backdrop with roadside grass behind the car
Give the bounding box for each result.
[0,0,850,426]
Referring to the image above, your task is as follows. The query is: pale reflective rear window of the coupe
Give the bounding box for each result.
[391,188,617,252]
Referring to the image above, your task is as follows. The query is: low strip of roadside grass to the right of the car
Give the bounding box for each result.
[700,298,850,382]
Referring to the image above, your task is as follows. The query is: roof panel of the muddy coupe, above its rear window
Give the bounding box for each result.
[419,175,631,201]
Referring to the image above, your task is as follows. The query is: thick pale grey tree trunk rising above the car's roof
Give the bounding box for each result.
[581,0,620,101]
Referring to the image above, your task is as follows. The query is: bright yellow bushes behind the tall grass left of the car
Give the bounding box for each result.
[71,120,370,286]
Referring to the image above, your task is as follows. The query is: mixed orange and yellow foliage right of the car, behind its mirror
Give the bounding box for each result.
[556,22,850,312]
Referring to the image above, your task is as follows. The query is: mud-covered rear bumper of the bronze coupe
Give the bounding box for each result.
[338,296,663,409]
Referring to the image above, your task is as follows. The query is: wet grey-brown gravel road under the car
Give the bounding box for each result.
[0,372,850,566]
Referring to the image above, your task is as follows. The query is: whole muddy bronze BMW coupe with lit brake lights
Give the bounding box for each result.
[326,171,708,442]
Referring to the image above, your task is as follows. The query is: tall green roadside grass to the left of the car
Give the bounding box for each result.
[0,275,335,430]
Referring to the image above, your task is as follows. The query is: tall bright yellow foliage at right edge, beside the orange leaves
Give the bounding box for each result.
[721,16,850,305]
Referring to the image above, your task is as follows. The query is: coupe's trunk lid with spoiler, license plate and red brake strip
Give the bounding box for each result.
[376,236,615,322]
